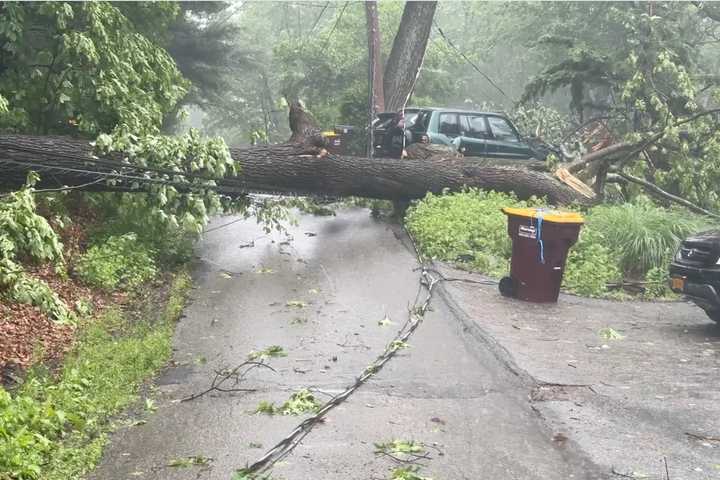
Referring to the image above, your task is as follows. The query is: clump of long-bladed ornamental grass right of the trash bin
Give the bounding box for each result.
[587,197,707,278]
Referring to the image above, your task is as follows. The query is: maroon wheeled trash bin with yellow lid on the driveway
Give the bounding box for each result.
[500,208,584,302]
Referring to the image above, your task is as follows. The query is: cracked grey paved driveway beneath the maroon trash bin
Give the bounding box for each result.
[438,264,720,480]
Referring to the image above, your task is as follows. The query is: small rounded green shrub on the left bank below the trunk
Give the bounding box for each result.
[76,233,157,290]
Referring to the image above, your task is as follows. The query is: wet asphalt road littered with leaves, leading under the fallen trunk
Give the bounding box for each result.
[90,208,606,480]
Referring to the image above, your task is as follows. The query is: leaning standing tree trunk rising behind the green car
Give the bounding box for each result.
[383,1,437,111]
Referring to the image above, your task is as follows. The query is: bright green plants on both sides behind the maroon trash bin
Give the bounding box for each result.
[405,189,710,298]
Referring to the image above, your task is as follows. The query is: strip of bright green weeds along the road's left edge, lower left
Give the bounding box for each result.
[0,272,190,480]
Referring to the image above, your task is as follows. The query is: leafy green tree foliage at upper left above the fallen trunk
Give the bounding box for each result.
[0,2,187,135]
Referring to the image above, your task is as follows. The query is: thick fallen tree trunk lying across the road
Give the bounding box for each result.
[0,135,587,204]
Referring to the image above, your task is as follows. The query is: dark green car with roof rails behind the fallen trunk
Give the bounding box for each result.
[374,108,553,160]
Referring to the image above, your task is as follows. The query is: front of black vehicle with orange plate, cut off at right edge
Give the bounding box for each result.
[670,230,720,323]
